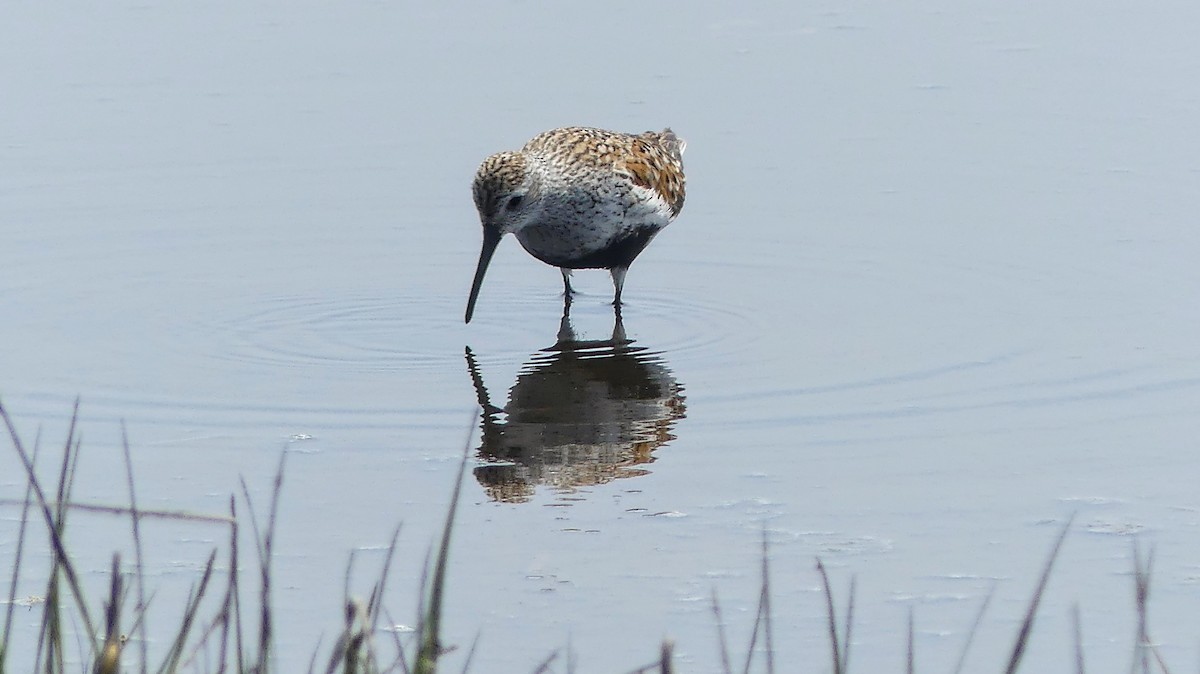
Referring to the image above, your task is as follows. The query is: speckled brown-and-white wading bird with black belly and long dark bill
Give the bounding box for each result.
[467,127,685,323]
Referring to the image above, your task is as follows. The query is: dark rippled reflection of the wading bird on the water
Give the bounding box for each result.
[467,303,685,503]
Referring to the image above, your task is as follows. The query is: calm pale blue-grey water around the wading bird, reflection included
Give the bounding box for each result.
[0,2,1200,672]
